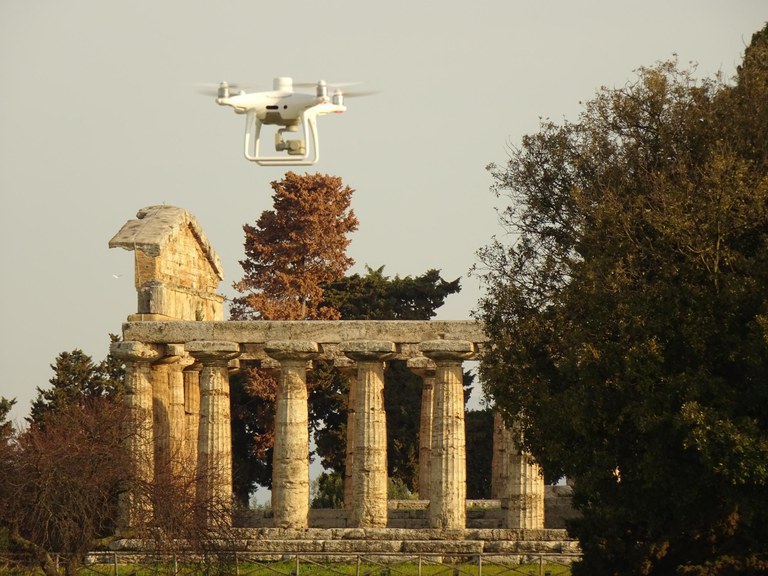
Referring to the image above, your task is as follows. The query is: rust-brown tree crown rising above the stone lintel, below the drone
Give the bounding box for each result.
[230,172,358,320]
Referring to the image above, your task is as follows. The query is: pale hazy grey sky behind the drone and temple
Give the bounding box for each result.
[0,0,768,420]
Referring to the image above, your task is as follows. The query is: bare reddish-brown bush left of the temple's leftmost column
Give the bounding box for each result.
[0,397,130,576]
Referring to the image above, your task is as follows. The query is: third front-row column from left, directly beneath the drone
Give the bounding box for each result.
[264,340,318,528]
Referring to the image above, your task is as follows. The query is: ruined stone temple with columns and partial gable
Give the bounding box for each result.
[109,206,576,553]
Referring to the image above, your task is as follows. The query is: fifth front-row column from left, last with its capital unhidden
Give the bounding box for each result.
[419,340,475,530]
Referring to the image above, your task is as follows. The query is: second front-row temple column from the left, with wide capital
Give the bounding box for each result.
[186,340,240,527]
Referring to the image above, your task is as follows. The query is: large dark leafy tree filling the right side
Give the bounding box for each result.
[477,29,768,574]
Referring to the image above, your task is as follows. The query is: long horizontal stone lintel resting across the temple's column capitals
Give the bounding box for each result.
[123,320,487,348]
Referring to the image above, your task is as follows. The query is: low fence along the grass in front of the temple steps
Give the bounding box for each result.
[0,551,580,576]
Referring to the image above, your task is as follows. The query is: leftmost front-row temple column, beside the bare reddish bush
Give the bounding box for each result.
[110,342,162,530]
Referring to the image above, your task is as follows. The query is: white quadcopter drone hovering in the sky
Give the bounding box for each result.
[207,77,356,166]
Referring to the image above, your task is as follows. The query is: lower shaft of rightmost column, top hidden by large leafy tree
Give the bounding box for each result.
[500,421,544,529]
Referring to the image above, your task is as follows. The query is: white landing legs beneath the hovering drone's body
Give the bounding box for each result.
[243,113,320,166]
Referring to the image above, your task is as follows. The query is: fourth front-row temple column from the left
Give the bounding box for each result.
[340,340,395,528]
